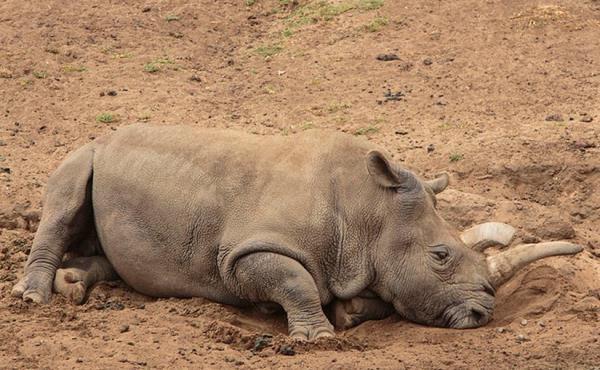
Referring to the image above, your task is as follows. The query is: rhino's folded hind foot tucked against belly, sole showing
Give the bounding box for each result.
[54,256,119,304]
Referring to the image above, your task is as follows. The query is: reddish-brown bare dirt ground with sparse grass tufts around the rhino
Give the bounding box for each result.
[0,0,600,369]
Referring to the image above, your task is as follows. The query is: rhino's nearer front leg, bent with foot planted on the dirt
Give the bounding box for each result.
[226,252,334,340]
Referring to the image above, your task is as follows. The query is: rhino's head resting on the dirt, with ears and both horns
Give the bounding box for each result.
[367,151,582,328]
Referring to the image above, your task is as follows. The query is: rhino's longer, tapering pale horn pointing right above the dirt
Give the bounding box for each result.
[487,242,583,288]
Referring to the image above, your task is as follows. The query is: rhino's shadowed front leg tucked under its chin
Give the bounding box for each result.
[331,297,395,330]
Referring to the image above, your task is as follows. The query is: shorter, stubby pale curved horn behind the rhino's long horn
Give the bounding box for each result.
[460,222,516,251]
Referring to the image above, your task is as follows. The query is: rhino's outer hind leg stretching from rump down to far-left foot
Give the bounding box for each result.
[12,144,94,303]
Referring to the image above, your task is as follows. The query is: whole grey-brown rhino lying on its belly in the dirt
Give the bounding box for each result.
[12,125,581,339]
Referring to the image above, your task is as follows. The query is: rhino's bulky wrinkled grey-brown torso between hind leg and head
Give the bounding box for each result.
[92,126,376,304]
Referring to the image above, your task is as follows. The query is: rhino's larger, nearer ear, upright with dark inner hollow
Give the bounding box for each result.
[367,150,417,190]
